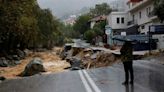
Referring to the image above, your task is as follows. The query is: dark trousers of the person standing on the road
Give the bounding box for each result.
[123,61,134,82]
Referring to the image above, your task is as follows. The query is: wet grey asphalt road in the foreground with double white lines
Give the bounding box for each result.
[0,61,164,92]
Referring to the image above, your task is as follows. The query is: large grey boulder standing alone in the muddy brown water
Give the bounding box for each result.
[20,58,45,76]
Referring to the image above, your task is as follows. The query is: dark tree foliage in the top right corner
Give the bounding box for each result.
[154,0,164,22]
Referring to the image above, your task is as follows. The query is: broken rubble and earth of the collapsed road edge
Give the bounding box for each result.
[60,47,116,70]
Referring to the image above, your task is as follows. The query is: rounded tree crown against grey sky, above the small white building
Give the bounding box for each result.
[90,3,112,17]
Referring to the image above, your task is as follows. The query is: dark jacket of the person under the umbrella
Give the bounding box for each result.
[120,41,133,62]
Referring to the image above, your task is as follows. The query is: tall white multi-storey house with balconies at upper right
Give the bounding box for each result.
[127,0,159,34]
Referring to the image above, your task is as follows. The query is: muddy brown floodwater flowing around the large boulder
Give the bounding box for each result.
[0,48,70,79]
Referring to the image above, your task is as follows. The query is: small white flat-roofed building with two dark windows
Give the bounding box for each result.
[106,12,128,45]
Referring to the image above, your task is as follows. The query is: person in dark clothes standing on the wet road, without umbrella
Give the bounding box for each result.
[120,41,134,85]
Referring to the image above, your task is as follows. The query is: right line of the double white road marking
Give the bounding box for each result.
[82,70,101,92]
